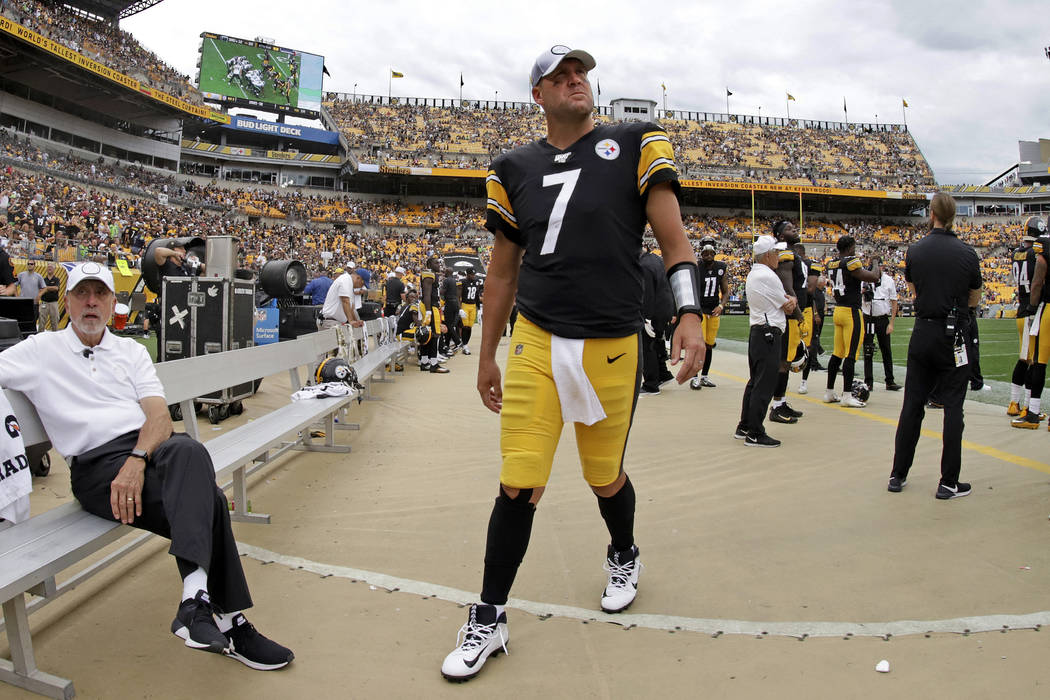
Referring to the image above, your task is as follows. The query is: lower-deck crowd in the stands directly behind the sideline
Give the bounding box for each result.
[0,129,1020,304]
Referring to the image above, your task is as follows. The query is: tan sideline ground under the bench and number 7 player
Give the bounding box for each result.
[0,335,1050,698]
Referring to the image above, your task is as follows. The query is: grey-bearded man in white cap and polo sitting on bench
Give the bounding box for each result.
[0,262,293,671]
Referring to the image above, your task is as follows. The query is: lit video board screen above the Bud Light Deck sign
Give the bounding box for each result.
[197,31,324,116]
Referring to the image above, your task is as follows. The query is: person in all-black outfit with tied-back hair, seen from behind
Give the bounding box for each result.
[887,192,981,500]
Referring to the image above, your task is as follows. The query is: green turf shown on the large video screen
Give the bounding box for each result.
[201,38,301,107]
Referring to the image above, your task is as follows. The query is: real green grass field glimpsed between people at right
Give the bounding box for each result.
[718,316,1017,382]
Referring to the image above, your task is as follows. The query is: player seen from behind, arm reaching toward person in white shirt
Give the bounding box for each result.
[824,235,882,408]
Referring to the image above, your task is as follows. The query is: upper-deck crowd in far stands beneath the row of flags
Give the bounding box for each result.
[326,99,936,191]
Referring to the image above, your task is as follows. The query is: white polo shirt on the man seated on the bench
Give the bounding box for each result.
[0,326,164,459]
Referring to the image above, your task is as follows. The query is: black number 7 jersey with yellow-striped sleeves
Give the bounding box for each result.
[485,122,678,338]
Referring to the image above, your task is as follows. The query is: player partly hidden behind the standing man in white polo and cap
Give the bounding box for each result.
[770,220,810,424]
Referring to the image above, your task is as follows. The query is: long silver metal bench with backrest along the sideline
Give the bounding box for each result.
[0,319,407,698]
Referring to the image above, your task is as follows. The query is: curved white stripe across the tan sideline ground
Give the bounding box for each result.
[237,542,1050,637]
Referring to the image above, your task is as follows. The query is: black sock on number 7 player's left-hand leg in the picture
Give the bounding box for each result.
[481,486,536,606]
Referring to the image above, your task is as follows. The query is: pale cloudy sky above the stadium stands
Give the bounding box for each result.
[121,0,1050,184]
